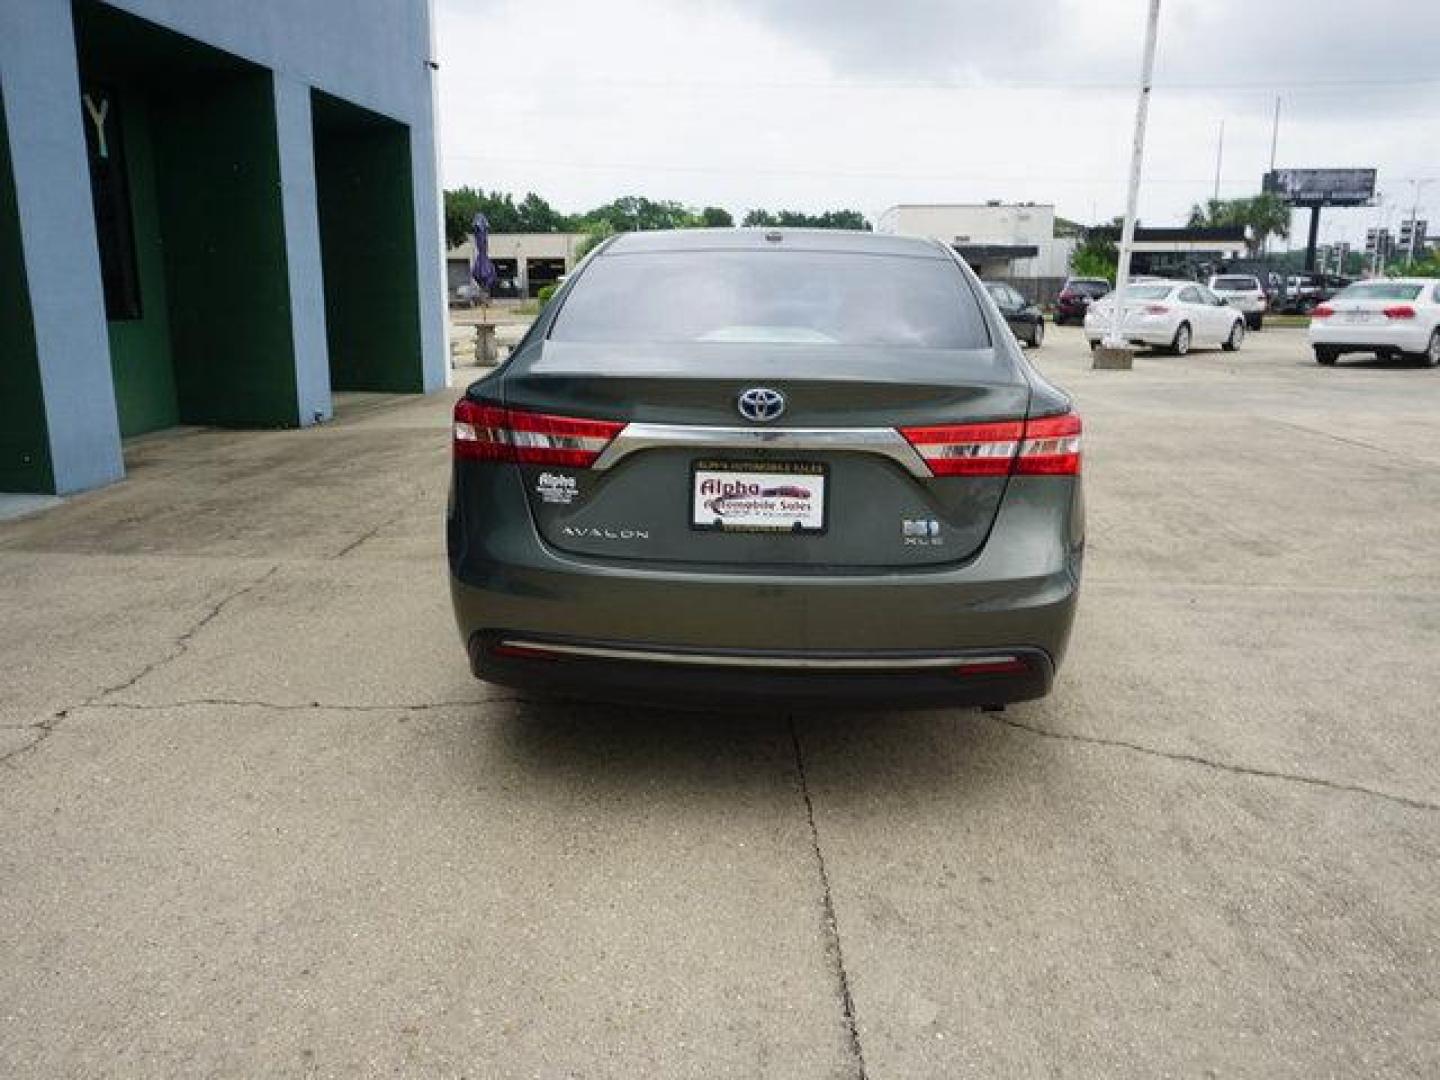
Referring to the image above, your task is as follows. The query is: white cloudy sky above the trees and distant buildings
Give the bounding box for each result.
[435,0,1440,246]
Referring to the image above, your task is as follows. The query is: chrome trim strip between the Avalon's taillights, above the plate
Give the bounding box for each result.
[590,423,935,480]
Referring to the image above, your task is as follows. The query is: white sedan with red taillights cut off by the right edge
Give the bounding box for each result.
[1310,278,1440,367]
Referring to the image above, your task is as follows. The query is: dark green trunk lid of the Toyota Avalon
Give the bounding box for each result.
[503,341,1030,573]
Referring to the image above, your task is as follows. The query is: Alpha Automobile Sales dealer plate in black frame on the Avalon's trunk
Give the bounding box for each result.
[690,461,825,533]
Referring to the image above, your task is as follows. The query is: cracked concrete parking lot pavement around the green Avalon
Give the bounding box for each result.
[0,328,1440,1080]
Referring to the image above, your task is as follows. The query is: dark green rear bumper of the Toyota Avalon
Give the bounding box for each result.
[449,477,1083,706]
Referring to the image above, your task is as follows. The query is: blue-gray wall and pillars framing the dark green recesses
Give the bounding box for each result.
[0,0,446,492]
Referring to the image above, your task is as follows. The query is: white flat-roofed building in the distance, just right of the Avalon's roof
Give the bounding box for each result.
[876,202,1076,281]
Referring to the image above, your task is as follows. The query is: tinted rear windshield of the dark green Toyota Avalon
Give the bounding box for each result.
[550,251,989,348]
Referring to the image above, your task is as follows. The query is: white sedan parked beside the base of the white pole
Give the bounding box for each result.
[1084,281,1246,356]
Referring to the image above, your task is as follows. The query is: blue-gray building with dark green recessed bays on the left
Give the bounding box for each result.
[0,0,446,494]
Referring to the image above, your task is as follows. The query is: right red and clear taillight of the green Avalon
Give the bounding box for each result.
[900,412,1080,477]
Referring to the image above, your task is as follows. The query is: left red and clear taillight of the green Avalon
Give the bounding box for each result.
[454,397,625,468]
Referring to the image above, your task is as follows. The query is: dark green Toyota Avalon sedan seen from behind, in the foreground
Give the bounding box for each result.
[448,229,1084,708]
